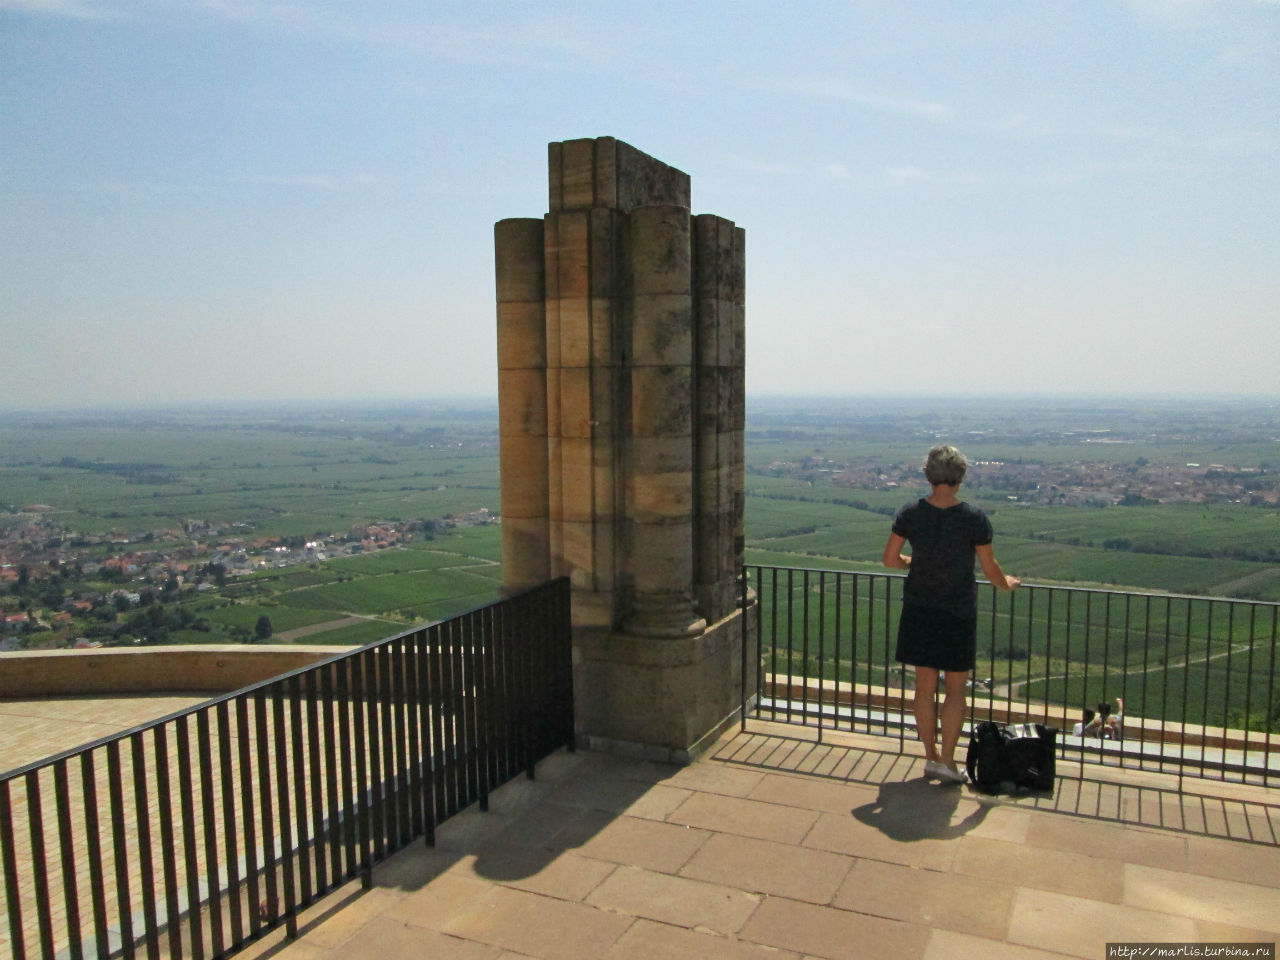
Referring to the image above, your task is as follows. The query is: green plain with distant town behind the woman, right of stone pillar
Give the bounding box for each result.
[746,401,1280,600]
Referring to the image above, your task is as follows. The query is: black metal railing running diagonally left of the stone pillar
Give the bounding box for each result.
[0,580,573,960]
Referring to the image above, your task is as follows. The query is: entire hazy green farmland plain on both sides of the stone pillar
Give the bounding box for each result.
[0,399,1280,660]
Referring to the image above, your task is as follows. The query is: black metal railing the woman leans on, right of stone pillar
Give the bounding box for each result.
[744,566,1280,785]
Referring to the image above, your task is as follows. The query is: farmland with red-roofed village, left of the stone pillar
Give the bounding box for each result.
[0,404,502,646]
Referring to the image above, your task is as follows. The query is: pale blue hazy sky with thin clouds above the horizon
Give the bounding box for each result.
[0,0,1280,410]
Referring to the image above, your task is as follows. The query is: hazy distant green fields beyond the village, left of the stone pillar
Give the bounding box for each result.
[0,410,499,545]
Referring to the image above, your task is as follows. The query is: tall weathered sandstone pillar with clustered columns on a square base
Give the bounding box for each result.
[494,137,754,760]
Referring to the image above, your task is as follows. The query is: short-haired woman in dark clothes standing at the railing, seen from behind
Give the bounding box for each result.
[884,445,1021,783]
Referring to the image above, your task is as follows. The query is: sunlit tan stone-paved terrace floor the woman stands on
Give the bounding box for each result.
[0,700,1280,960]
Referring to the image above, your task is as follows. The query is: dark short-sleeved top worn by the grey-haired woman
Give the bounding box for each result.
[893,499,992,618]
